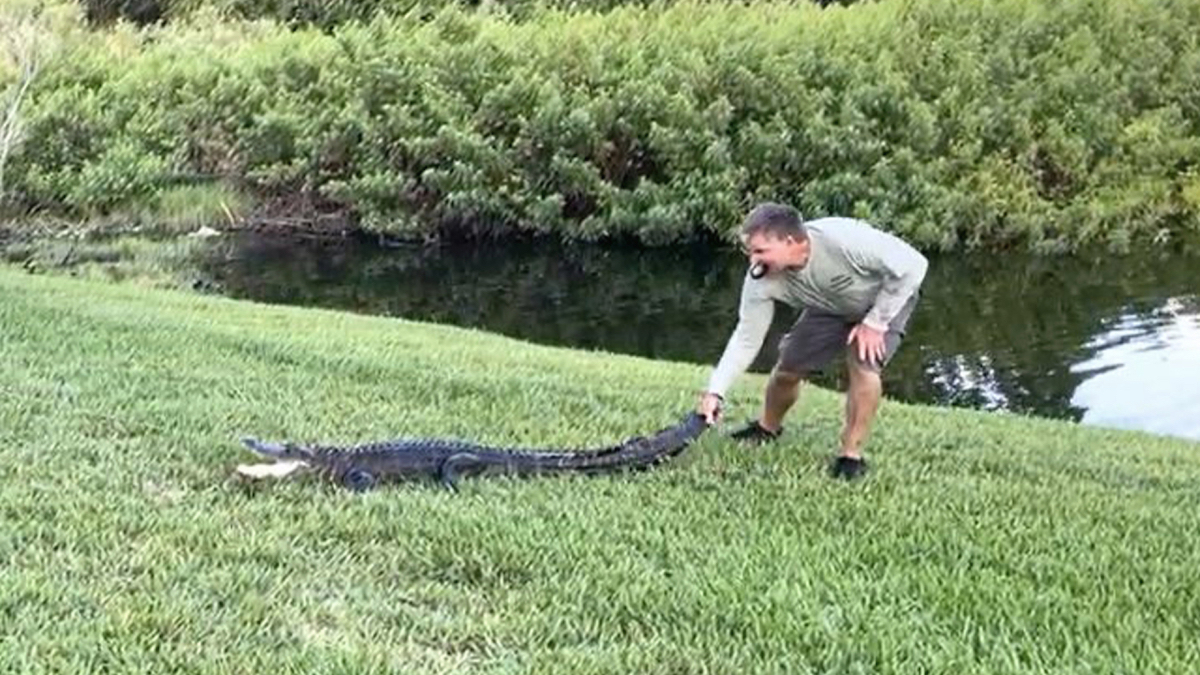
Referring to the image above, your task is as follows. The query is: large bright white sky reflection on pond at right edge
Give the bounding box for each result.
[1072,297,1200,440]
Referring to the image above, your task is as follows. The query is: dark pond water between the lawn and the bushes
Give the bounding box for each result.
[204,233,1200,440]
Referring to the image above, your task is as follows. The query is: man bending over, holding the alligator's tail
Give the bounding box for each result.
[697,203,928,479]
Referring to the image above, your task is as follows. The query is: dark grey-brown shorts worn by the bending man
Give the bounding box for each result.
[775,291,920,375]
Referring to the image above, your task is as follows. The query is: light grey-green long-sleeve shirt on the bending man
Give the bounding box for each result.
[708,217,929,396]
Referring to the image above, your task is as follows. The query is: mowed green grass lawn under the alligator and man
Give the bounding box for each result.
[0,268,1200,674]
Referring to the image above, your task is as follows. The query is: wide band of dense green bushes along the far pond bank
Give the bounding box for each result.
[10,0,1200,249]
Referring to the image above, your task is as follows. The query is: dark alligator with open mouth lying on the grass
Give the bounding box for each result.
[238,412,708,491]
